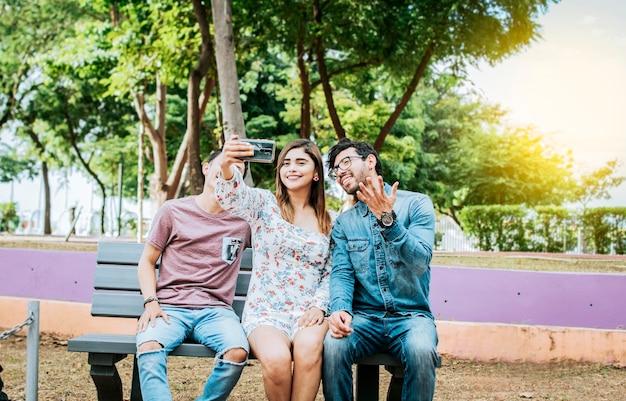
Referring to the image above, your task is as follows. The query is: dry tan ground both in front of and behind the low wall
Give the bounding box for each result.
[0,235,626,401]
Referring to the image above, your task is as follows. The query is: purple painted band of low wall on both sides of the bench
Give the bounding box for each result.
[0,248,626,329]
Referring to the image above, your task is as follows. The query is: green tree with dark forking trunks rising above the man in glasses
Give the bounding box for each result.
[238,0,558,151]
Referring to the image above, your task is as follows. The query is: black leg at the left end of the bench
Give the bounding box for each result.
[88,352,126,401]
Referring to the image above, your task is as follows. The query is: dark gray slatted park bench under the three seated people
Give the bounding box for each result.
[67,242,441,401]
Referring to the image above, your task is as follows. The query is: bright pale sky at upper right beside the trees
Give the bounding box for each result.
[469,0,626,206]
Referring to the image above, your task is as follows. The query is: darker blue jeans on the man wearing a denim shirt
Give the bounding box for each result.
[322,313,438,401]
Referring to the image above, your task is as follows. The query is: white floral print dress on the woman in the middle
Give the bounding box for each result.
[215,171,331,339]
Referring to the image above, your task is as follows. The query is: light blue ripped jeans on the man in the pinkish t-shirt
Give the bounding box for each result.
[136,306,250,401]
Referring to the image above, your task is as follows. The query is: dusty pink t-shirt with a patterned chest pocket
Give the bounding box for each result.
[146,196,250,309]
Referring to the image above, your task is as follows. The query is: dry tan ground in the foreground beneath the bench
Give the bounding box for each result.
[0,334,626,401]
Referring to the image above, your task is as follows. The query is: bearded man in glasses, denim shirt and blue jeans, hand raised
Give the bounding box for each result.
[323,139,438,401]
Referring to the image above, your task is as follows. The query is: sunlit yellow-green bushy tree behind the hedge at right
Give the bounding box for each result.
[372,74,573,221]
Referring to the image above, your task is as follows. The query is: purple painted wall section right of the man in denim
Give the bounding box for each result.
[430,266,626,329]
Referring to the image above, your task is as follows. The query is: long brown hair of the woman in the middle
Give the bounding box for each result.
[276,139,332,235]
